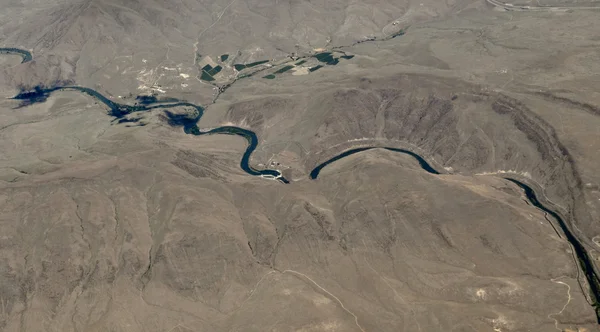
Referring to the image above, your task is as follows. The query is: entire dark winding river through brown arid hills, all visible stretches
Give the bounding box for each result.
[0,48,600,324]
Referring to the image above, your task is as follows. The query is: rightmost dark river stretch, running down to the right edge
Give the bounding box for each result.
[505,178,600,324]
